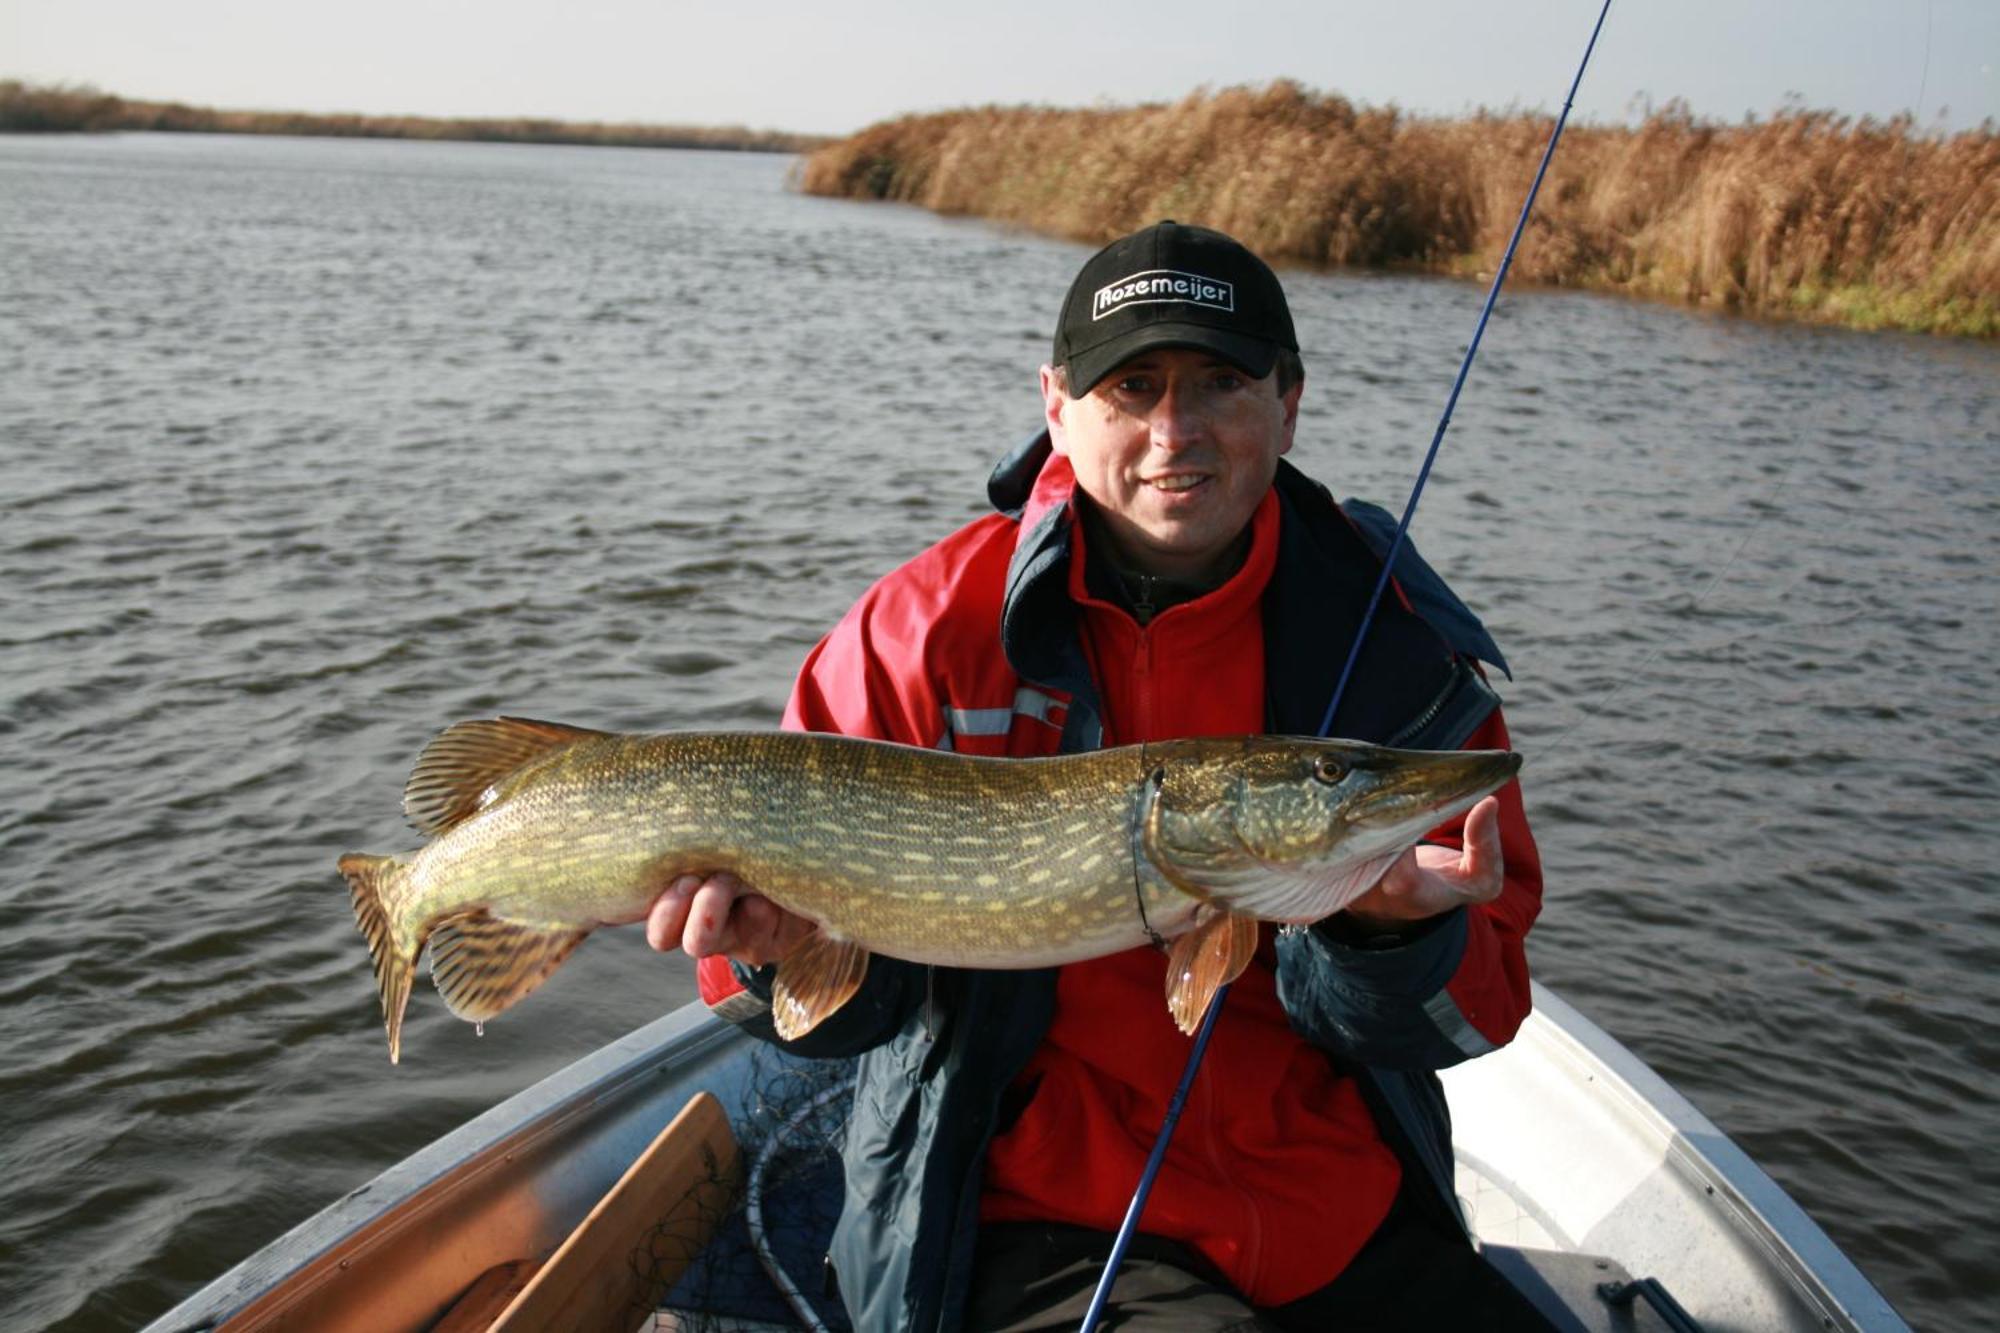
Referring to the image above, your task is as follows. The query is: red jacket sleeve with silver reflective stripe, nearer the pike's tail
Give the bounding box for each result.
[696,584,944,1057]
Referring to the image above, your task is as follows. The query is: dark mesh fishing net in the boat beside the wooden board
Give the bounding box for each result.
[636,1043,854,1333]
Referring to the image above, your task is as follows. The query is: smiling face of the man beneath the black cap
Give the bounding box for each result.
[1042,348,1300,580]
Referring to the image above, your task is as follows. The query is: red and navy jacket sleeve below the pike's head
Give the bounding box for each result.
[1278,709,1542,1069]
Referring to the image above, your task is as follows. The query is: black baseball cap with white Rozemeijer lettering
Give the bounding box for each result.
[1056,220,1298,396]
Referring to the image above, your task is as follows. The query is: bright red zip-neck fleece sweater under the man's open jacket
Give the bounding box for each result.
[980,496,1400,1305]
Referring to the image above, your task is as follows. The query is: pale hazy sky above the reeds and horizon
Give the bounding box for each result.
[0,0,2000,134]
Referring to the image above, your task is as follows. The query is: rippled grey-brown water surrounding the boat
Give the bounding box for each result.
[0,136,2000,1331]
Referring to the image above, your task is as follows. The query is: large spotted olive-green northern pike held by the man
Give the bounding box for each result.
[340,719,1520,1061]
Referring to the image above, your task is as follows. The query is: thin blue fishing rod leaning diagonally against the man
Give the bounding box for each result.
[1078,0,1612,1333]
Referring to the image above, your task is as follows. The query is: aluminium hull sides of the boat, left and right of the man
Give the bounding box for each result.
[148,985,1908,1333]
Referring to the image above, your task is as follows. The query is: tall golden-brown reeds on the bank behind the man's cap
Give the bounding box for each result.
[796,80,2000,338]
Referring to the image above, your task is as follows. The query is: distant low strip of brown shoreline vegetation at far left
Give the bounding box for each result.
[0,80,828,152]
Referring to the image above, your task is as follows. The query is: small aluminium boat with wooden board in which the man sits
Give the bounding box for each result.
[148,983,1908,1333]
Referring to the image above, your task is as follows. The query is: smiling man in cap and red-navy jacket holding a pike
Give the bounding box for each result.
[648,222,1540,1333]
